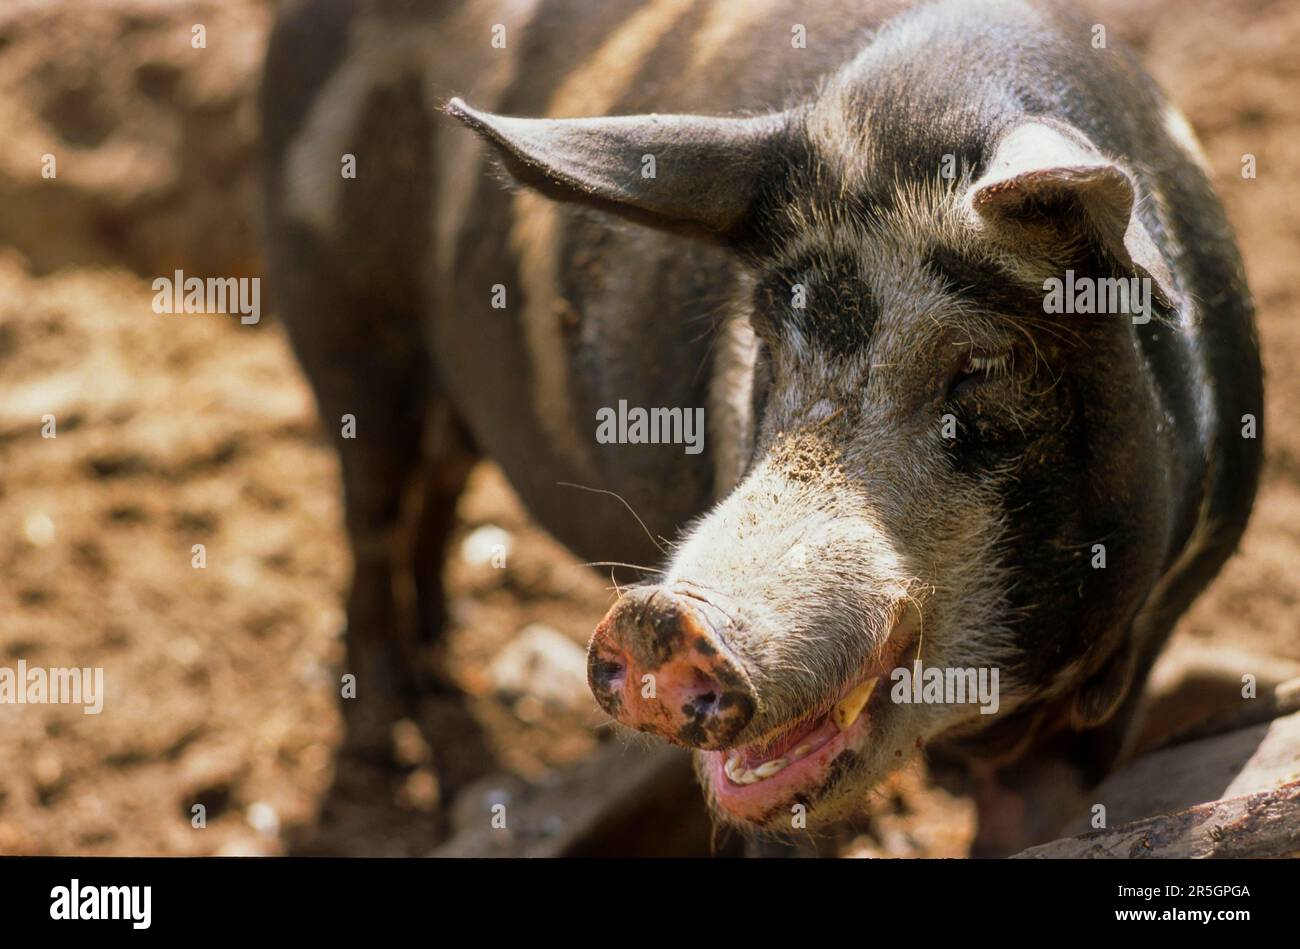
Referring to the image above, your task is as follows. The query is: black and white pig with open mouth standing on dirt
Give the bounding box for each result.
[263,0,1262,854]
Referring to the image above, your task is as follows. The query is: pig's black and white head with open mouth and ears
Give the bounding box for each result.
[450,75,1174,832]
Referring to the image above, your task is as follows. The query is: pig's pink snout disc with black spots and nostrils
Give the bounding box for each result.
[586,586,757,750]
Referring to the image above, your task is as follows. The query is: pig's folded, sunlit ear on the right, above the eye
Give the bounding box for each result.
[966,120,1178,307]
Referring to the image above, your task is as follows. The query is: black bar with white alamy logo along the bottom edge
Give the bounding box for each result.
[0,857,1279,941]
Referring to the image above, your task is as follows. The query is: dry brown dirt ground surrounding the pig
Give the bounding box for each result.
[0,0,1300,855]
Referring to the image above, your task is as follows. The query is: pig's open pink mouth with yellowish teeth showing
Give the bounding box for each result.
[699,623,914,824]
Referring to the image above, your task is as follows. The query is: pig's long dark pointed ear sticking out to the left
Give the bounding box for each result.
[447,99,785,238]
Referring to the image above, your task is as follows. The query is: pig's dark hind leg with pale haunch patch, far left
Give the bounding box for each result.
[263,16,457,763]
